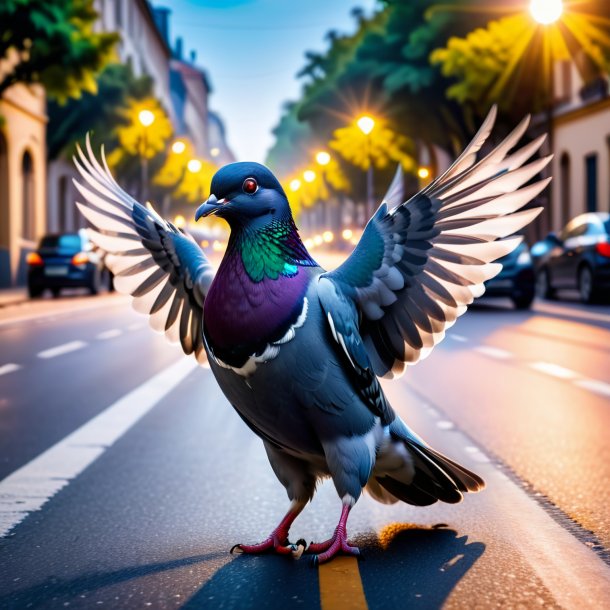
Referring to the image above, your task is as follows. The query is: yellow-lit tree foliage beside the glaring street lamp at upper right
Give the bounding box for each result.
[431,3,610,121]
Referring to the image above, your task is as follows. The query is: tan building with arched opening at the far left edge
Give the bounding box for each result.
[0,49,47,287]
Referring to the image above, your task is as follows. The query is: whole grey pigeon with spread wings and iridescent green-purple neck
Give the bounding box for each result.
[74,108,551,564]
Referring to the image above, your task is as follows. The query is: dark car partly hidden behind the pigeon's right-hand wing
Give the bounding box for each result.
[485,242,535,309]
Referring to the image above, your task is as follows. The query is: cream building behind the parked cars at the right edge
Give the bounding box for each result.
[548,62,610,231]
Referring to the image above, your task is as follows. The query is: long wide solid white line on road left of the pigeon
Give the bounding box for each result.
[0,358,197,538]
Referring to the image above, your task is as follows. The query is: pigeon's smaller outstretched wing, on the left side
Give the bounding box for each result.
[74,136,214,364]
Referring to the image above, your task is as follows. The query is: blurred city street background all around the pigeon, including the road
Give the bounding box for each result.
[0,0,610,608]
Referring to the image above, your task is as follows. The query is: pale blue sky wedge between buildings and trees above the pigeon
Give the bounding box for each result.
[158,0,376,163]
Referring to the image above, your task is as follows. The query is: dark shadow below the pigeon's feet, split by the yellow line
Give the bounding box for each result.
[184,523,485,610]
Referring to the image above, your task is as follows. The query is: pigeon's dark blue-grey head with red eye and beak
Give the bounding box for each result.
[195,162,290,227]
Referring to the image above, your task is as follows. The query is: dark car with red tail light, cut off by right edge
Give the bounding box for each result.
[532,212,610,303]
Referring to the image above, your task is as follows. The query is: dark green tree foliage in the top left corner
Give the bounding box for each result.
[0,0,119,102]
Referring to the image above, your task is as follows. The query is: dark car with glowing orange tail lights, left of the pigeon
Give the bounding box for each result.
[27,231,103,298]
